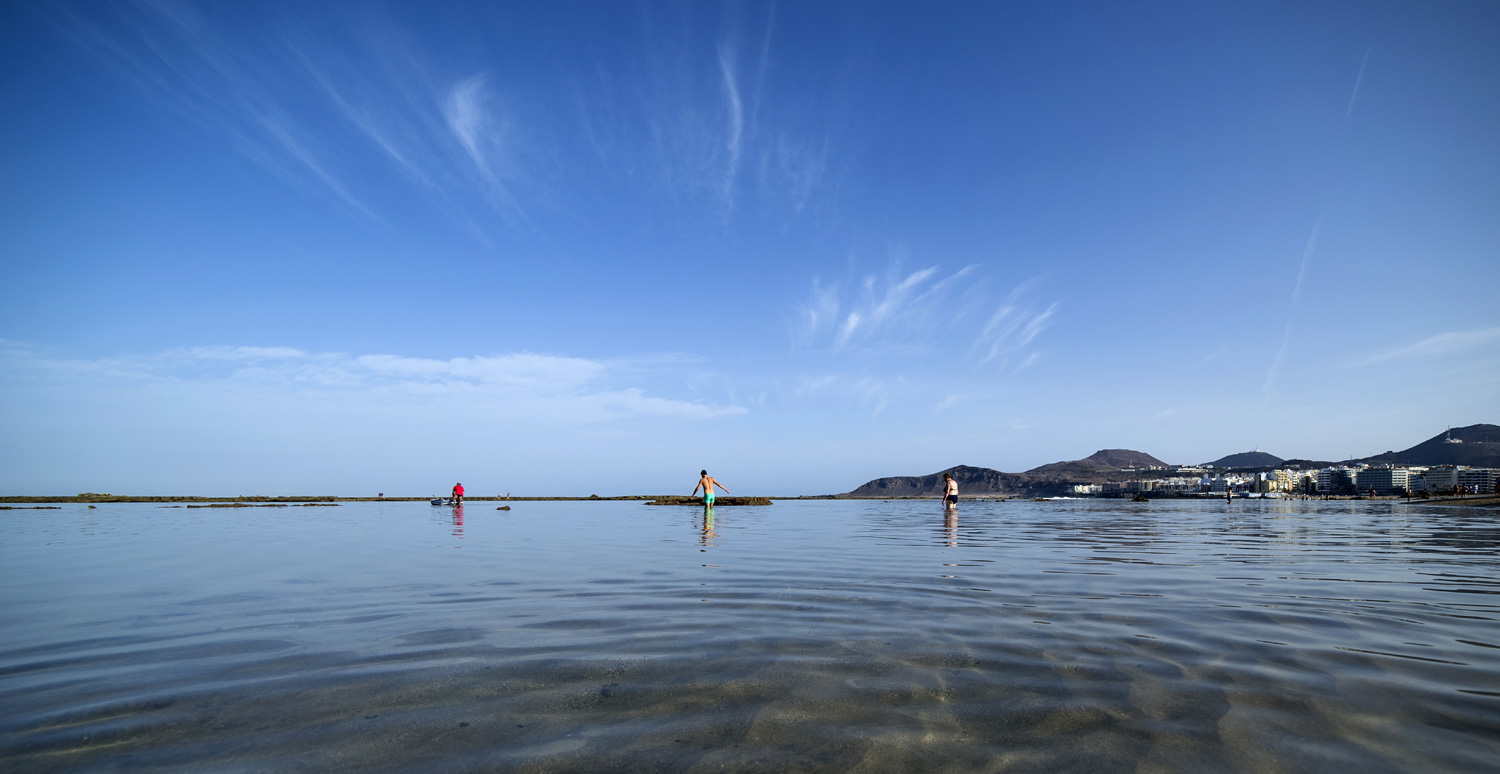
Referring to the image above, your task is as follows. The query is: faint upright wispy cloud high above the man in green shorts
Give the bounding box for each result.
[573,5,828,224]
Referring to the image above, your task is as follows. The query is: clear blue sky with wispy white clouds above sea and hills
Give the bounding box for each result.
[0,0,1500,495]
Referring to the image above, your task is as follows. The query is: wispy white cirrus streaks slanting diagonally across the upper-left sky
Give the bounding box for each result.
[57,0,537,231]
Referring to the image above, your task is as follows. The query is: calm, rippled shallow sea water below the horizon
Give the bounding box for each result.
[0,501,1500,773]
